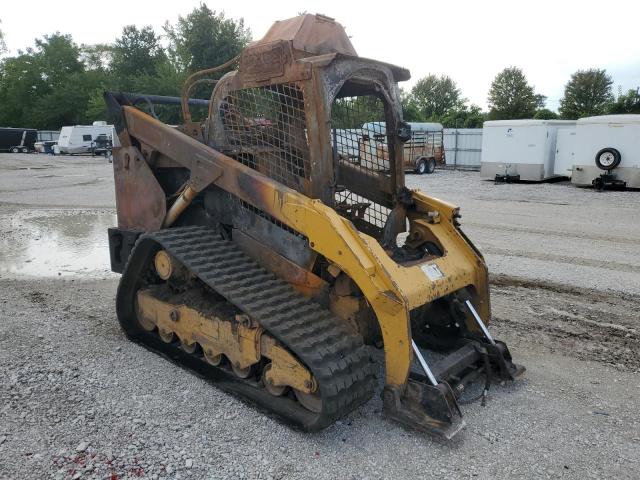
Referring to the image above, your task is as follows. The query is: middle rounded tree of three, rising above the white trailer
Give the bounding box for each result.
[488,67,545,120]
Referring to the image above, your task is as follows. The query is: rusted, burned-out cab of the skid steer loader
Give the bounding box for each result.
[205,15,408,221]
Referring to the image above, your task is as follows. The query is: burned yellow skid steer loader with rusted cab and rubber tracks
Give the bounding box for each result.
[105,15,523,438]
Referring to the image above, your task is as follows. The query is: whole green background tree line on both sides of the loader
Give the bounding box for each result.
[0,9,640,130]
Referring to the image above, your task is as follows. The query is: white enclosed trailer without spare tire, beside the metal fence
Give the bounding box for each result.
[480,120,575,181]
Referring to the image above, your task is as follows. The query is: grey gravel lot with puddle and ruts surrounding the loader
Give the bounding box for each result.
[0,154,640,479]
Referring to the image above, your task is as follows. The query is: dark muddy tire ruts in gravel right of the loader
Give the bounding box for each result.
[491,276,640,372]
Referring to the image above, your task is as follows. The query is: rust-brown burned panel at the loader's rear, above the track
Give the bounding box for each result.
[113,147,166,231]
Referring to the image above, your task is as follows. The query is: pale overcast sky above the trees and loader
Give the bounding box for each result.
[0,0,640,110]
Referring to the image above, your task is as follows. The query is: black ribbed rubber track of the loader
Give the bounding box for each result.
[118,227,374,430]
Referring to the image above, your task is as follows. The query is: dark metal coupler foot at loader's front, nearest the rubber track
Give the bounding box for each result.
[382,378,465,440]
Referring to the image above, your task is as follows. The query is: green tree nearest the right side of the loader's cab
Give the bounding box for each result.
[411,75,464,119]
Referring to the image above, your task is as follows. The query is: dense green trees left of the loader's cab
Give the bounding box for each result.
[0,4,251,130]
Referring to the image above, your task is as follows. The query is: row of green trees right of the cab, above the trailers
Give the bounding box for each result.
[402,67,640,128]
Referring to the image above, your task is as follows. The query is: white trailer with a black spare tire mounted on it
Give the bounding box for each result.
[571,115,640,189]
